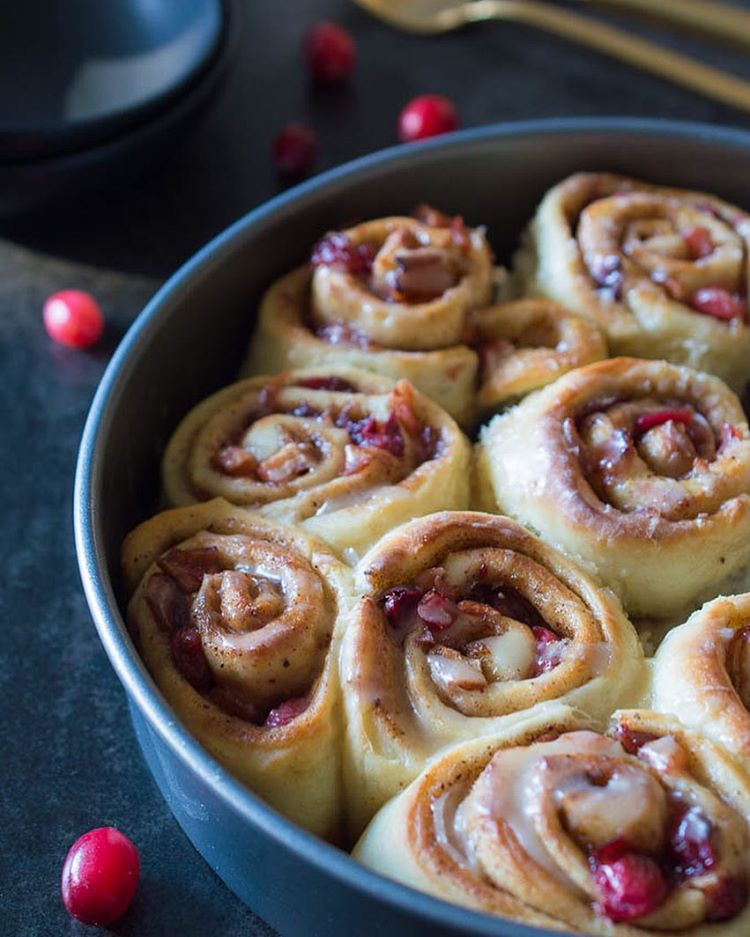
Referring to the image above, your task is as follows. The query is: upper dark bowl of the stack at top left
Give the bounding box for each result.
[0,0,223,163]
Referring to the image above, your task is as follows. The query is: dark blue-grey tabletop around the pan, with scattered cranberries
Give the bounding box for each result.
[0,0,750,937]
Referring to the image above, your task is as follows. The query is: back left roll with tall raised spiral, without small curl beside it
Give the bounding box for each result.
[243,207,494,425]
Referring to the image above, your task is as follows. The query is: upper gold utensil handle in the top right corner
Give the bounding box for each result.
[582,0,750,48]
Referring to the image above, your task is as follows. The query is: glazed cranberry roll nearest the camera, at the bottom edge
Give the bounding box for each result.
[355,710,750,937]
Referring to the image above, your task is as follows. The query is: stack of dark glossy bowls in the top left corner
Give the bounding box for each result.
[0,0,233,217]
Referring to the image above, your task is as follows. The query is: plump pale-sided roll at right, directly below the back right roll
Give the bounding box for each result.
[477,358,750,617]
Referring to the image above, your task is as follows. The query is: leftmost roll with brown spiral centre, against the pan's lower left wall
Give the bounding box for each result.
[123,499,351,837]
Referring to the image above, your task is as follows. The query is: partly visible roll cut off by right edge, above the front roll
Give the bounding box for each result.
[653,593,750,767]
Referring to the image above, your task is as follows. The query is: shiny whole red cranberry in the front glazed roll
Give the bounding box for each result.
[589,840,667,922]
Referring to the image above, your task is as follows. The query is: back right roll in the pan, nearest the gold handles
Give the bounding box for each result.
[519,173,750,390]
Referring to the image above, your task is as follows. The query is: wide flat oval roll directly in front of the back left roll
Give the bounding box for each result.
[162,368,470,558]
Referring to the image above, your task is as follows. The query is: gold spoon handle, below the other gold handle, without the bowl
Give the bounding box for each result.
[468,0,750,111]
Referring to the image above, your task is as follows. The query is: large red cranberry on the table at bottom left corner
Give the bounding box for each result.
[62,826,140,927]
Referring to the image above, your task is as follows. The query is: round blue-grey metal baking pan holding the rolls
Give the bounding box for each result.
[75,119,750,937]
